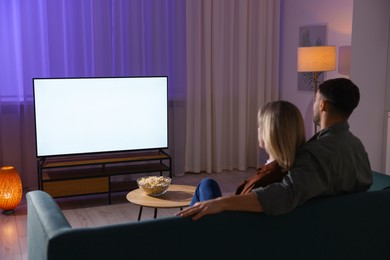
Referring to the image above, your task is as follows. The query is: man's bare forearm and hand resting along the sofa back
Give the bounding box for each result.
[176,192,263,220]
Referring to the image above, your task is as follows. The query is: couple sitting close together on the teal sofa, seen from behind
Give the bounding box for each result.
[177,78,372,220]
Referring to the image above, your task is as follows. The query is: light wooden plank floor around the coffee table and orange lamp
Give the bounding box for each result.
[0,169,255,260]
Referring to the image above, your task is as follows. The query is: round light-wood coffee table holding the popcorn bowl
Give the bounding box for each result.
[126,184,196,220]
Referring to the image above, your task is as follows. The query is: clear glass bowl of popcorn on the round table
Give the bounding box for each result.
[137,176,172,197]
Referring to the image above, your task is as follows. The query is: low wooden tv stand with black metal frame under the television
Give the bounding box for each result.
[37,150,172,204]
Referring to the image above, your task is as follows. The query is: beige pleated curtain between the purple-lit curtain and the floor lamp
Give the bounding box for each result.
[185,0,280,173]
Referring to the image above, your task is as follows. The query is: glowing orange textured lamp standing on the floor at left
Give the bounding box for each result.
[0,166,22,213]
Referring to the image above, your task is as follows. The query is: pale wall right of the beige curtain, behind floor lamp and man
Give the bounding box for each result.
[280,0,390,175]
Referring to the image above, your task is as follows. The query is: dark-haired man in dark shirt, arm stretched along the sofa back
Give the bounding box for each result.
[177,78,372,220]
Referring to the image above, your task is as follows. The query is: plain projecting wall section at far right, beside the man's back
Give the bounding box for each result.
[350,0,390,174]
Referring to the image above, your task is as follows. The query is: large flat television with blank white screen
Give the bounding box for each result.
[33,76,168,157]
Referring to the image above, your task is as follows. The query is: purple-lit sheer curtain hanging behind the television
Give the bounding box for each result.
[0,0,186,190]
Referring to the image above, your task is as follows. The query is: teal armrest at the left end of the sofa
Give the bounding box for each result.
[26,190,71,260]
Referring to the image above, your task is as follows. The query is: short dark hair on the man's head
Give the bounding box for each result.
[318,78,360,117]
